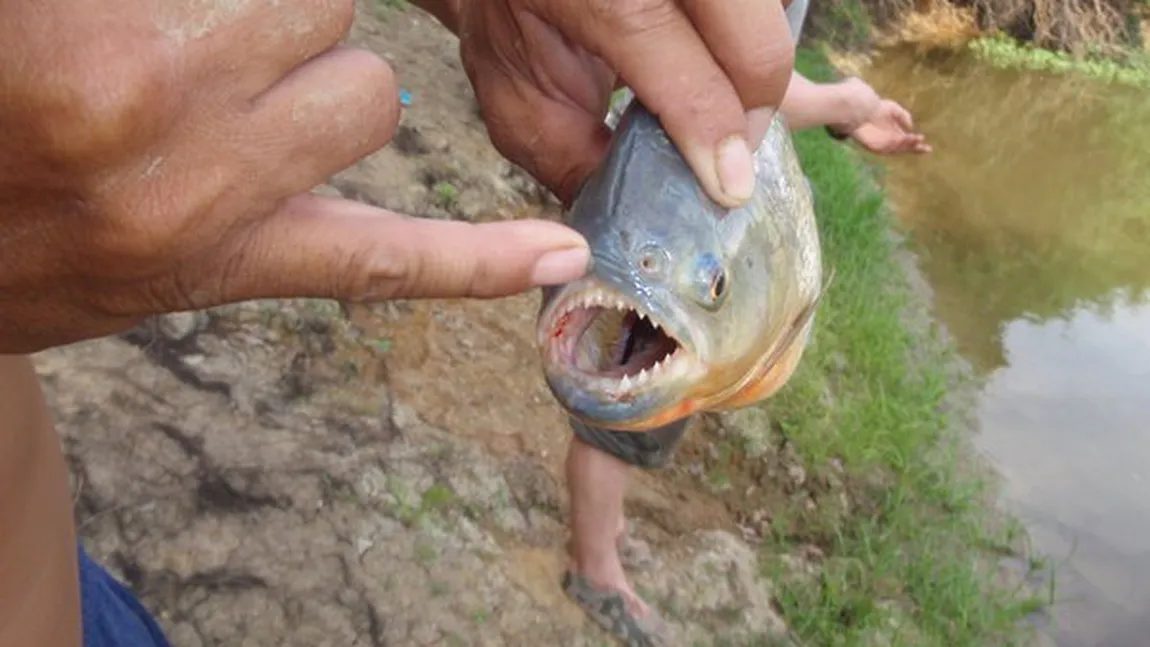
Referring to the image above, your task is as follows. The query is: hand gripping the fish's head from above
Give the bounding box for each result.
[443,0,794,207]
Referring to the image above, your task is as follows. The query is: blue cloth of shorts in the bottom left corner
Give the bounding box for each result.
[79,547,170,647]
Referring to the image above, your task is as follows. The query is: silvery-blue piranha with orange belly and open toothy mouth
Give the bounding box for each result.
[537,100,826,431]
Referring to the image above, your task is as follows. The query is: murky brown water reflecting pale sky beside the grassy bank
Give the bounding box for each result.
[864,48,1150,647]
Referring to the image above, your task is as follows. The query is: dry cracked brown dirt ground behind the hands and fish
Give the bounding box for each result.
[38,3,804,647]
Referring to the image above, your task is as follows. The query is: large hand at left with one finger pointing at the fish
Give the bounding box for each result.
[0,0,593,353]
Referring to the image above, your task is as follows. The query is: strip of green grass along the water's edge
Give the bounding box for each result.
[766,48,1053,647]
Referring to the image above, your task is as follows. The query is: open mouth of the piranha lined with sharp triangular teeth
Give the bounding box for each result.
[549,287,688,392]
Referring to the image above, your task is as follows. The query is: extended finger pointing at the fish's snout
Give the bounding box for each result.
[201,194,590,302]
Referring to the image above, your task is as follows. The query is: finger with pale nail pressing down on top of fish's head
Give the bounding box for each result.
[531,0,791,207]
